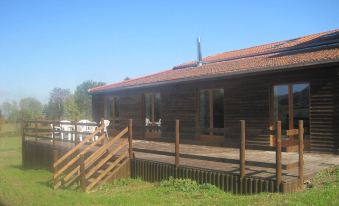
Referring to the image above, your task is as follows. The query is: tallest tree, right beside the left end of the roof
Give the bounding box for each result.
[74,80,105,119]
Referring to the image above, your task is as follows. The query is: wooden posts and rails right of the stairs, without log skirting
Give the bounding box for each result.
[133,120,304,192]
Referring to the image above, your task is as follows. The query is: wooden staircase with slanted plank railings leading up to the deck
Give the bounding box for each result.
[53,120,132,192]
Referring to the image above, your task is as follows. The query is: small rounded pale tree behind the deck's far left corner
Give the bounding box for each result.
[19,97,43,119]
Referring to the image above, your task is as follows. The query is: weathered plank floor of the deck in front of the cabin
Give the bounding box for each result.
[26,139,339,182]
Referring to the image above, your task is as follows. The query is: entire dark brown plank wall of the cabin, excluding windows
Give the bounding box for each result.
[93,65,339,153]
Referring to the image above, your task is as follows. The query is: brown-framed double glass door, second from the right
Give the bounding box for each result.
[199,89,224,135]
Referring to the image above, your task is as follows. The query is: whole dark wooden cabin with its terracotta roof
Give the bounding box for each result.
[89,30,339,153]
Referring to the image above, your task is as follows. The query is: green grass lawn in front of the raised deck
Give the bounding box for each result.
[0,123,339,206]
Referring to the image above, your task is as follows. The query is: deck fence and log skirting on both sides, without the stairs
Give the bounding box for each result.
[22,120,304,194]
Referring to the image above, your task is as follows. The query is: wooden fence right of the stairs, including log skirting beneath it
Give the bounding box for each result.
[132,120,304,194]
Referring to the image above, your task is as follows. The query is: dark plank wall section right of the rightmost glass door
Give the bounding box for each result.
[310,68,339,152]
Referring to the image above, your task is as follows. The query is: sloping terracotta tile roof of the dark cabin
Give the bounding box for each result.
[89,30,339,93]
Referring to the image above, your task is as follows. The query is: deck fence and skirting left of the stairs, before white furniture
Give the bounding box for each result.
[21,120,99,170]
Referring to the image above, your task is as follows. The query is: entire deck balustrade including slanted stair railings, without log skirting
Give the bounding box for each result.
[22,119,304,192]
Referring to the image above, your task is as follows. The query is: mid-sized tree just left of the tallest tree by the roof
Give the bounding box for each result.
[44,87,71,120]
